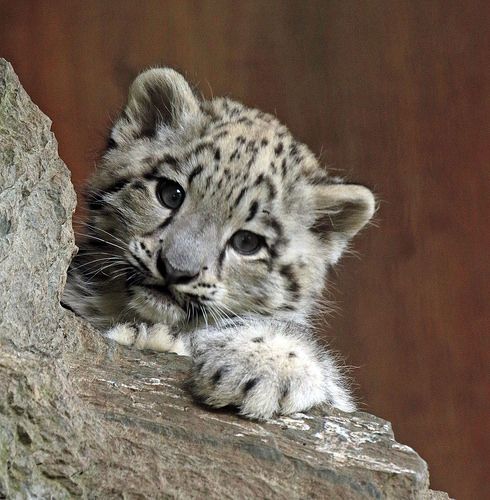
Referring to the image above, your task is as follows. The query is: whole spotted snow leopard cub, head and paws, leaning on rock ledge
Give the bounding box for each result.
[63,68,375,419]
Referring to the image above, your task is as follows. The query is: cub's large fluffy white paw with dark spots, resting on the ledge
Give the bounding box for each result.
[192,322,355,419]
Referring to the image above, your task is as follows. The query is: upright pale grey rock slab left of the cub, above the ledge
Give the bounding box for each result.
[0,60,76,354]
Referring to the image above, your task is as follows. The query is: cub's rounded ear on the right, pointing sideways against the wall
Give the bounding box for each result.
[313,184,376,240]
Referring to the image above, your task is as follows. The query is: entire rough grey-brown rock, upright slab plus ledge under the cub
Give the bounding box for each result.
[0,60,447,499]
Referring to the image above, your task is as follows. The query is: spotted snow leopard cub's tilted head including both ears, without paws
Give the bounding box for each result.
[84,69,374,323]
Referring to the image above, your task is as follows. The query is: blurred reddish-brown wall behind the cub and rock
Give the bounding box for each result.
[0,0,490,499]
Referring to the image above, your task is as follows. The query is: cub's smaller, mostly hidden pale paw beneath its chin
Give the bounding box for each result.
[105,323,188,356]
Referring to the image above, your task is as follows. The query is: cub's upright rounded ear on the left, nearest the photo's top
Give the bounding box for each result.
[108,68,200,149]
